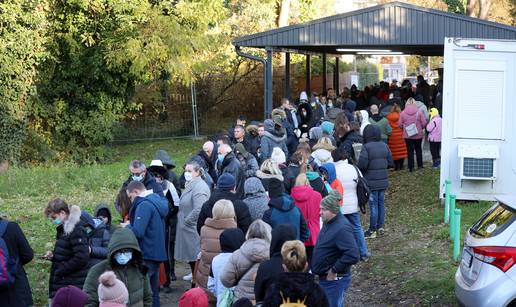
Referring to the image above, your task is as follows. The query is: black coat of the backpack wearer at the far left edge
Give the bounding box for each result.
[0,218,34,307]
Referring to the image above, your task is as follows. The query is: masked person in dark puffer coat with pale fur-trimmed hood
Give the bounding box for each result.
[44,198,90,300]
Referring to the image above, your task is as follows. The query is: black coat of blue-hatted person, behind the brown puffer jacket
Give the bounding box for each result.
[197,189,253,234]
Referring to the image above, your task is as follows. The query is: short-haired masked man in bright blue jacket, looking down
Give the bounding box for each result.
[121,181,168,307]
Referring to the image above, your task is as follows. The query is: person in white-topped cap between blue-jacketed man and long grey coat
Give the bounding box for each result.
[149,160,179,293]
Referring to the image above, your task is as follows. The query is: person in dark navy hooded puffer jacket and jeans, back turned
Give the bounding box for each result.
[358,125,394,239]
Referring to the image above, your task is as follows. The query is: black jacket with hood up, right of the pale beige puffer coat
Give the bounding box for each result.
[254,224,296,302]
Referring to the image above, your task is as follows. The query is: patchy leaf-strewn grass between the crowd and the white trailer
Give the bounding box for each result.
[366,169,491,305]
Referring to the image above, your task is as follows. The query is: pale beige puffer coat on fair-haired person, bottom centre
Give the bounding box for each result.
[220,239,270,301]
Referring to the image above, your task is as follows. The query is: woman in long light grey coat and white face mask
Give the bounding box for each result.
[174,161,210,284]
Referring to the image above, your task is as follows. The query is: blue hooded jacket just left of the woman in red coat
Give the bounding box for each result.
[263,193,310,242]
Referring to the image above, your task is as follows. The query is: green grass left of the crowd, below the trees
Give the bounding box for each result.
[0,140,201,306]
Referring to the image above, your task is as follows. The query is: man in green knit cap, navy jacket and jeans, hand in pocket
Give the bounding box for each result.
[312,190,360,307]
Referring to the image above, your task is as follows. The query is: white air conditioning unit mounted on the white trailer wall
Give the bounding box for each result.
[459,144,500,181]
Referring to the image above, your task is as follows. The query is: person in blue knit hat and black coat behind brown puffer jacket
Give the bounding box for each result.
[197,173,253,234]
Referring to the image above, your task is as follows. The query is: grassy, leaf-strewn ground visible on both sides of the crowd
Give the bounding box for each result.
[0,139,490,306]
